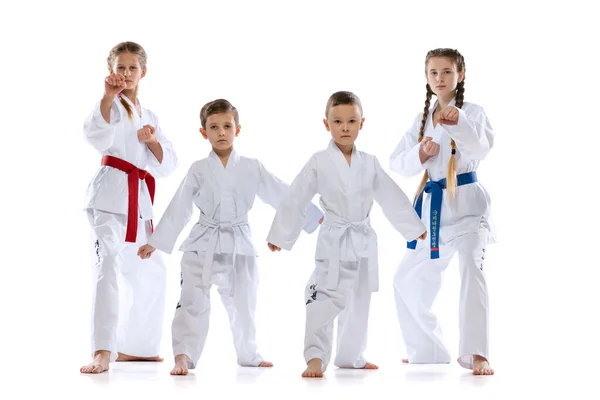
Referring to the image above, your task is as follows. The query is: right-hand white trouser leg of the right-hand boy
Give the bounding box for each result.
[334,259,371,368]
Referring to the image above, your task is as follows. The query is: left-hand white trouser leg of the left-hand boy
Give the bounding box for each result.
[171,252,210,369]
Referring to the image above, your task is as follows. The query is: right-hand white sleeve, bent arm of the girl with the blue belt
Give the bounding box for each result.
[441,107,494,160]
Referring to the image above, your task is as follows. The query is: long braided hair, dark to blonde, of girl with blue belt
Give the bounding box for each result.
[415,49,465,200]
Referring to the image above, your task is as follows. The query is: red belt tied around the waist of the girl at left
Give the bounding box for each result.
[102,156,156,243]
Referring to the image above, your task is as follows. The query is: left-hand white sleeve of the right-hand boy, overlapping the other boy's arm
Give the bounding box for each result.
[267,157,322,250]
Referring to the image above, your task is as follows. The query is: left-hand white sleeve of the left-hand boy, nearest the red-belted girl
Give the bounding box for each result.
[148,164,201,254]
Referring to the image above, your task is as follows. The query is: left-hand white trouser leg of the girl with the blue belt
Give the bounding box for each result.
[394,242,454,364]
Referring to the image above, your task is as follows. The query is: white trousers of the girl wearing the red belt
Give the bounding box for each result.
[88,210,166,361]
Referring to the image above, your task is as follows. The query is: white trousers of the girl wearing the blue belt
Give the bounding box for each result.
[394,228,489,369]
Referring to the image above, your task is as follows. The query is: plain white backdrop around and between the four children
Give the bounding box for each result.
[0,0,600,396]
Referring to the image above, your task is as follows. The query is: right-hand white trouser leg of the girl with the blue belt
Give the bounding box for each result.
[457,231,489,369]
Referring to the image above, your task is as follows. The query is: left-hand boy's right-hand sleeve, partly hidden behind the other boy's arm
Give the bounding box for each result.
[257,162,323,233]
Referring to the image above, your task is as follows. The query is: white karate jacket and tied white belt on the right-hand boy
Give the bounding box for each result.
[267,140,426,292]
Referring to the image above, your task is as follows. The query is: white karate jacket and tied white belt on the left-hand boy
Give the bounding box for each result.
[148,150,323,256]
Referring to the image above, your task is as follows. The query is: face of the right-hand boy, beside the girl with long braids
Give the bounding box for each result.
[323,104,365,146]
